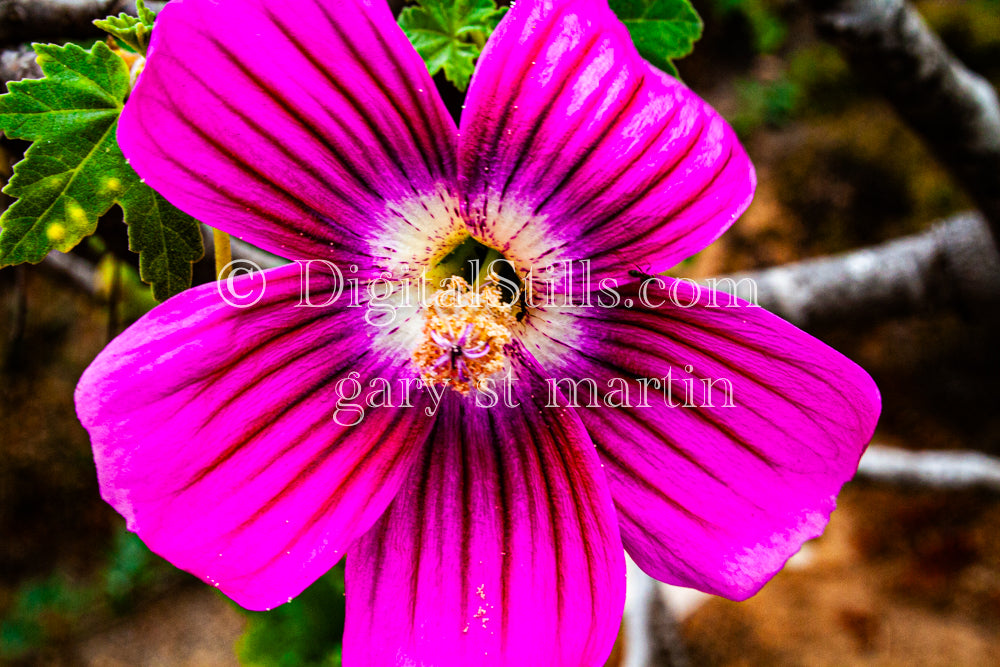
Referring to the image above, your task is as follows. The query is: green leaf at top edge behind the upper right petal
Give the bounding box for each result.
[610,0,703,76]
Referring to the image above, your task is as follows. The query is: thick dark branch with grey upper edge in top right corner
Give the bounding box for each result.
[806,0,1000,246]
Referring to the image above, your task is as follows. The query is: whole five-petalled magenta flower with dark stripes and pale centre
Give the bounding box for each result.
[77,0,879,667]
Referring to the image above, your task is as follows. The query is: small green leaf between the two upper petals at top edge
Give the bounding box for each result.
[399,0,507,91]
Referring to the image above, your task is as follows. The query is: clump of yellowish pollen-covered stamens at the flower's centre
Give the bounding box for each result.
[413,276,514,395]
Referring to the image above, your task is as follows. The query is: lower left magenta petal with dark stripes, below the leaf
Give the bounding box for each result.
[76,265,433,609]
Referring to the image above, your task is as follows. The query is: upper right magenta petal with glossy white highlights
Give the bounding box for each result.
[459,0,756,274]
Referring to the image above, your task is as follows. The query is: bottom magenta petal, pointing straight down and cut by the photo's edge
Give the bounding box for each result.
[344,350,625,667]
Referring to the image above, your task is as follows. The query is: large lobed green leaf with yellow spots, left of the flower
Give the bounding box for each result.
[0,42,204,300]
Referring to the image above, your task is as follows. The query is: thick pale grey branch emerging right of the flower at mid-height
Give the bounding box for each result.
[715,213,1000,330]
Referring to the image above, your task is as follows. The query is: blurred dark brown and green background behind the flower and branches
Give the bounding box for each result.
[0,0,1000,666]
